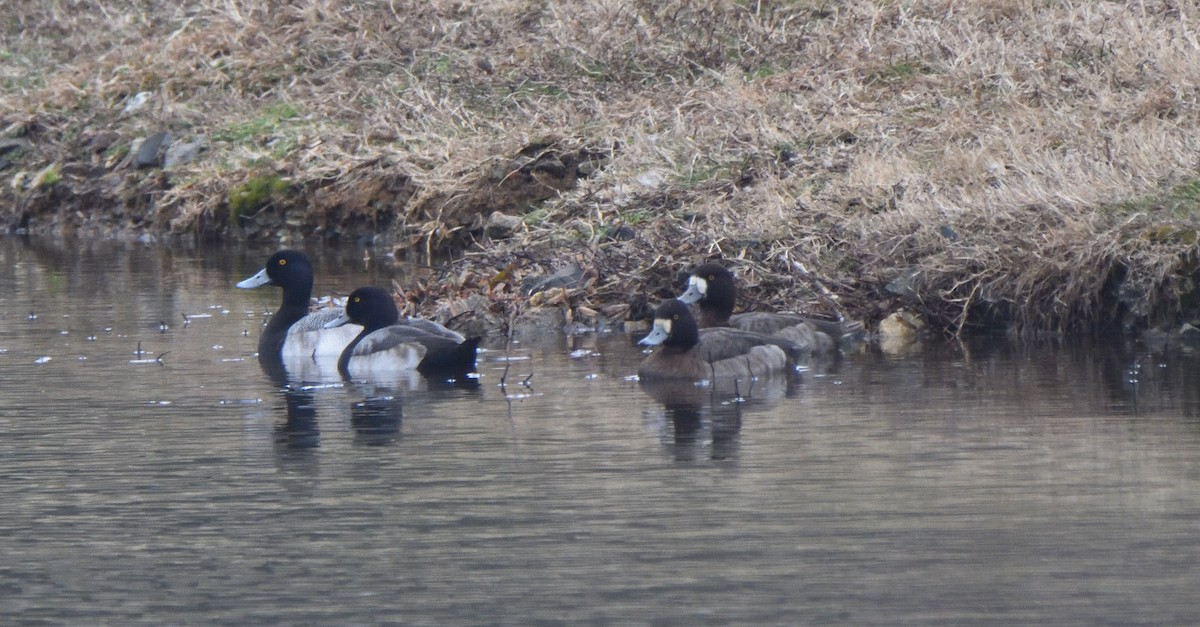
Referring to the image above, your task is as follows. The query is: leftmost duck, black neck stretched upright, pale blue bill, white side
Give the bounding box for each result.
[238,250,360,363]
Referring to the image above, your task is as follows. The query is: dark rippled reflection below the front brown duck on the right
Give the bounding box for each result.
[640,377,788,461]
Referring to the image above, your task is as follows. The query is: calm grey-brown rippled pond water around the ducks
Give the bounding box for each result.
[0,239,1200,625]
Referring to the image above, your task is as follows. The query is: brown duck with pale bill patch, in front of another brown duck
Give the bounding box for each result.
[637,298,802,381]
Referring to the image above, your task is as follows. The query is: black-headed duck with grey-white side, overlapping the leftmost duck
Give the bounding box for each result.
[325,286,480,380]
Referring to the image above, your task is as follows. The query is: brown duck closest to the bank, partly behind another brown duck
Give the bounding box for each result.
[678,262,863,354]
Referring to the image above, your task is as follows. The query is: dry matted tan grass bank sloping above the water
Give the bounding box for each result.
[0,0,1200,332]
